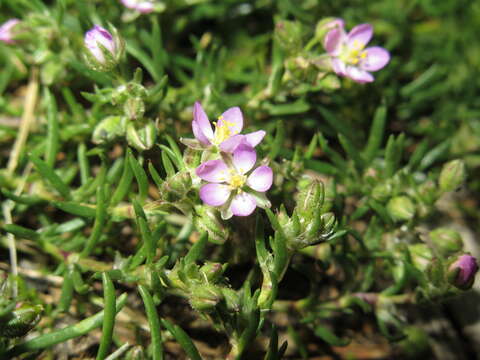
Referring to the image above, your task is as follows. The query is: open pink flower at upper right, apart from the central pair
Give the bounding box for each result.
[324,24,390,83]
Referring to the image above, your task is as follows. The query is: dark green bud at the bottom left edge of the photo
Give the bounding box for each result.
[0,303,43,338]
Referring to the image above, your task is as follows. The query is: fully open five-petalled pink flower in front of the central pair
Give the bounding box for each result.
[196,143,273,219]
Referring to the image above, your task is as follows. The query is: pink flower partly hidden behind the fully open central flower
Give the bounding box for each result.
[181,101,266,153]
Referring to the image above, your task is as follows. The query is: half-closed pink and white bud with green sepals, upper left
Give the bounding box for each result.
[84,25,123,71]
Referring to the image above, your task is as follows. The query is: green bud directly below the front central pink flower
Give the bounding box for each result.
[193,205,229,244]
